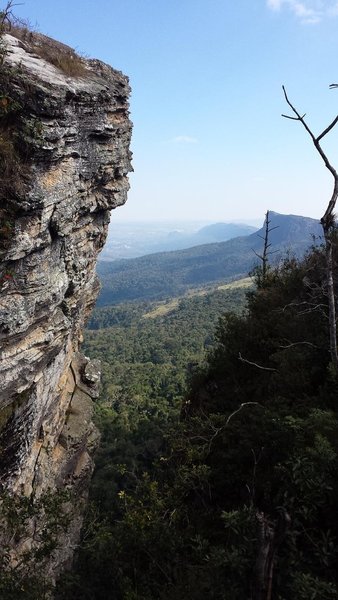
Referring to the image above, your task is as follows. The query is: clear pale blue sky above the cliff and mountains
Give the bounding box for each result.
[9,0,338,221]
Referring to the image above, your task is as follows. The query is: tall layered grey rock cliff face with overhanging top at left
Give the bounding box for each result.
[0,33,131,571]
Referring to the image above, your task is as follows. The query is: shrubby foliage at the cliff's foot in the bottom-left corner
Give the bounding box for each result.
[0,491,72,600]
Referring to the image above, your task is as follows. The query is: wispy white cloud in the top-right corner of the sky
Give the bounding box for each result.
[266,0,338,24]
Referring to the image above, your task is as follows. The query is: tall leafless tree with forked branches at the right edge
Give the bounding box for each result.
[282,84,338,372]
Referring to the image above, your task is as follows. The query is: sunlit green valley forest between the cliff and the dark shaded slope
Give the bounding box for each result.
[84,279,247,507]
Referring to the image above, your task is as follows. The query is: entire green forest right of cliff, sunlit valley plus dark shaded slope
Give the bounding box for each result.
[58,248,338,600]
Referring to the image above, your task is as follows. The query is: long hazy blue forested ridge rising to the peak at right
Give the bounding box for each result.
[98,211,322,306]
